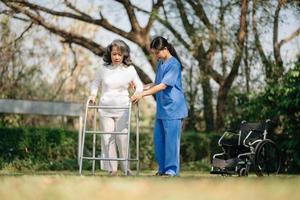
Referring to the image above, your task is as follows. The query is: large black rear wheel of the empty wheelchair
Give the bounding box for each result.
[254,139,280,176]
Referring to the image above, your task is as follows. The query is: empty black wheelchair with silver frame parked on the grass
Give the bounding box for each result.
[210,119,281,176]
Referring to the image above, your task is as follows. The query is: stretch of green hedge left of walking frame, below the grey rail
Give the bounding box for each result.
[0,128,77,170]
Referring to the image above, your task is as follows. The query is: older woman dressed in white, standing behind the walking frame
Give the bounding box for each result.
[89,40,143,175]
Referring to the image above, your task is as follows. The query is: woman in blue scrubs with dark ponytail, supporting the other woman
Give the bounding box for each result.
[131,36,188,176]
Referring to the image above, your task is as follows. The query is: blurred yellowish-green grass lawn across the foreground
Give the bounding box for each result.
[0,171,300,200]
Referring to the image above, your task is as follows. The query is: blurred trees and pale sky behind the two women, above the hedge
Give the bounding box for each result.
[0,0,300,172]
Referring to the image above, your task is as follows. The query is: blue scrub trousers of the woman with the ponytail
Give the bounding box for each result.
[154,119,182,176]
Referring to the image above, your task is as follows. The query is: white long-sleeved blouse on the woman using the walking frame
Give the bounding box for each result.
[91,64,143,117]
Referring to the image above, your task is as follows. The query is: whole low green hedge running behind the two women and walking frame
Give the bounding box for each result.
[0,127,221,171]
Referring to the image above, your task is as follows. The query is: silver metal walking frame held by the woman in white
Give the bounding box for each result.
[78,99,140,176]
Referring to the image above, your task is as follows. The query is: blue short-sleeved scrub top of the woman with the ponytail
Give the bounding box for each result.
[155,57,188,119]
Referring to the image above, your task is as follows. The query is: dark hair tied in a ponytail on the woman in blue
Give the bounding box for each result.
[150,36,183,69]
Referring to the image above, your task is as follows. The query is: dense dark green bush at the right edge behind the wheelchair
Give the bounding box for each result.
[229,58,300,172]
